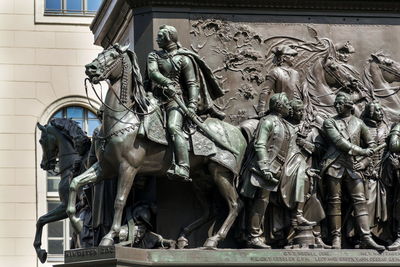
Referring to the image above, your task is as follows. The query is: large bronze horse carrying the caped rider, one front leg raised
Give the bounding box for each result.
[67,44,246,248]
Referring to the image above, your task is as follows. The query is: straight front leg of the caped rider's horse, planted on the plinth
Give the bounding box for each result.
[99,161,139,246]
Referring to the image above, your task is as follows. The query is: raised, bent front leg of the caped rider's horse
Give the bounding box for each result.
[66,162,101,233]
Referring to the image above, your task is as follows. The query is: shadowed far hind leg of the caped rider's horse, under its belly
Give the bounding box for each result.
[177,179,214,249]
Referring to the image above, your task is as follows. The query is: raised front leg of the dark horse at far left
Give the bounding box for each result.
[33,203,68,263]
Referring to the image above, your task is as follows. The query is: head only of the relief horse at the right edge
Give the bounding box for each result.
[368,52,400,83]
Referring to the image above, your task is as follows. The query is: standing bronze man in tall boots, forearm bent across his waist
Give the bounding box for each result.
[321,92,385,250]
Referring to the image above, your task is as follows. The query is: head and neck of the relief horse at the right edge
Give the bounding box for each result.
[362,52,400,122]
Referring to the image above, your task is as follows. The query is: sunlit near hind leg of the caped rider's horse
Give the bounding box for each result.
[203,163,243,249]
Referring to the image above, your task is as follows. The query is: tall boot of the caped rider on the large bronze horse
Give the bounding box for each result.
[167,134,192,182]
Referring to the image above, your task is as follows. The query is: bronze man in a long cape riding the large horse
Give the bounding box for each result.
[147,25,224,181]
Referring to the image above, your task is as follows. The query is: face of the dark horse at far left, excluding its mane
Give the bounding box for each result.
[36,123,58,171]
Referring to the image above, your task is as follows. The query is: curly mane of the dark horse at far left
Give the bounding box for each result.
[50,118,90,147]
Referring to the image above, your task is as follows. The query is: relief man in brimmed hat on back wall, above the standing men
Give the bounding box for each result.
[257,45,301,114]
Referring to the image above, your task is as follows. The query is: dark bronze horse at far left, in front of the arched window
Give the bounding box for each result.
[33,118,90,263]
